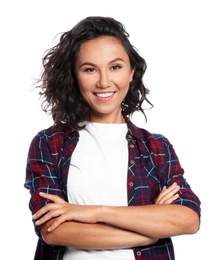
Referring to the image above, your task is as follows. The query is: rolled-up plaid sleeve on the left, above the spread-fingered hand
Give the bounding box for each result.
[24,131,64,236]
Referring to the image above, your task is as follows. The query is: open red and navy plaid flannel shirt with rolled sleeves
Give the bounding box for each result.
[24,117,200,260]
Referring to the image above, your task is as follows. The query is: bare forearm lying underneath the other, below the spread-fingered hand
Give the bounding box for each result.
[41,220,157,250]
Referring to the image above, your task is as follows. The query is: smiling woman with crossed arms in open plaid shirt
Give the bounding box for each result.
[25,17,200,260]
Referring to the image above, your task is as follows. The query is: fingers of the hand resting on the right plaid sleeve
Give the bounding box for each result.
[154,182,180,204]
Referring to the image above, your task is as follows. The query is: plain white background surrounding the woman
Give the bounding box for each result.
[0,0,220,260]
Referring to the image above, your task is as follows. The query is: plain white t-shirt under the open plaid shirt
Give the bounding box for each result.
[64,123,135,260]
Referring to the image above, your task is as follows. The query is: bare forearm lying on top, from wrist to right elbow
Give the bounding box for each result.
[100,204,199,238]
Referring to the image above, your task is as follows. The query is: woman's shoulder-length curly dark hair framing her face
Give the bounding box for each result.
[36,16,153,130]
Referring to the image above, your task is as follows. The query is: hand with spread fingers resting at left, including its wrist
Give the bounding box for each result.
[32,192,100,232]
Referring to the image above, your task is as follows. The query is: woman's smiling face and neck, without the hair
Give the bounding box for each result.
[75,36,134,123]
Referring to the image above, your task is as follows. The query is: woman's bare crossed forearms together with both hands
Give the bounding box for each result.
[33,183,199,250]
